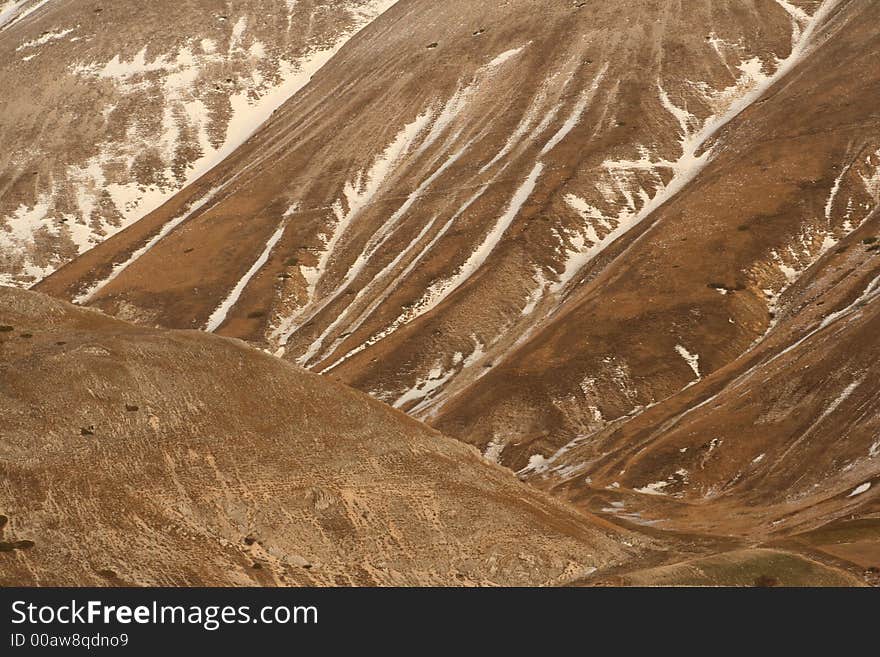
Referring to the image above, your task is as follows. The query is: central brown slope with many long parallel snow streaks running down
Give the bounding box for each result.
[44,0,809,352]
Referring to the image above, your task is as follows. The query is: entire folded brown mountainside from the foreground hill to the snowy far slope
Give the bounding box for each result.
[25,0,880,581]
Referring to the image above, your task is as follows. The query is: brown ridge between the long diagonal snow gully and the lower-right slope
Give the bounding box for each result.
[432,2,880,469]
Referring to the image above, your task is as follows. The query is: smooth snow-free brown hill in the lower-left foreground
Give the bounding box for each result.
[0,288,651,585]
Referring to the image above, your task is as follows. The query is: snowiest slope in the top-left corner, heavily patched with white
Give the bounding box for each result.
[0,0,393,285]
